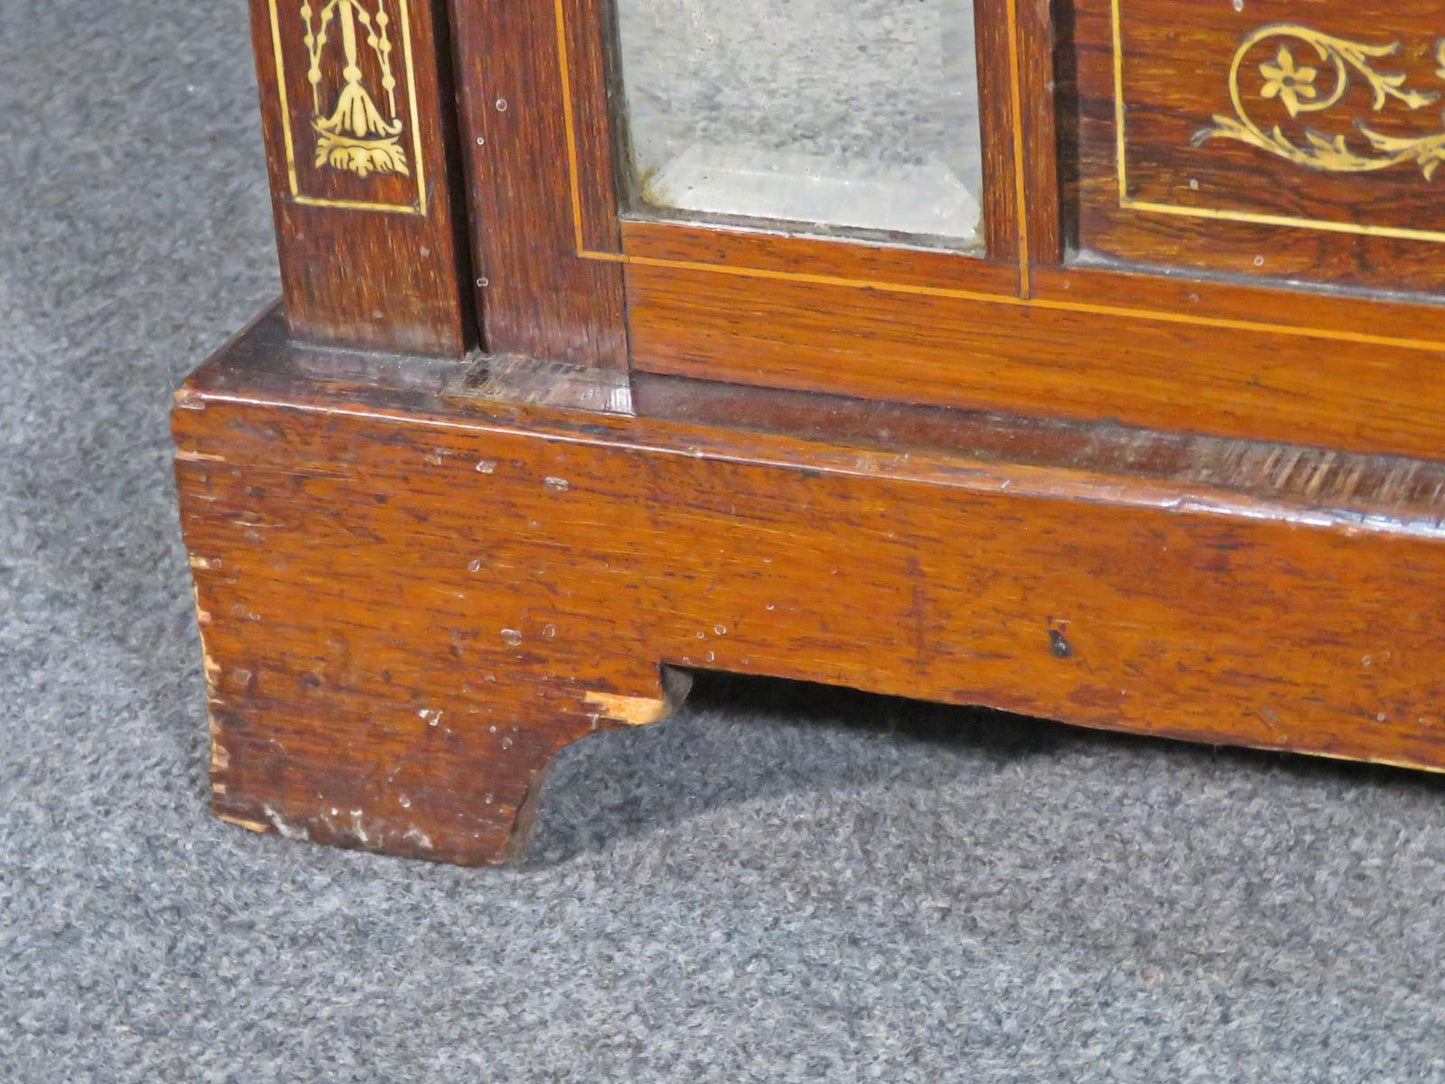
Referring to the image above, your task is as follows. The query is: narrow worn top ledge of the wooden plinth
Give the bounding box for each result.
[176,309,1445,538]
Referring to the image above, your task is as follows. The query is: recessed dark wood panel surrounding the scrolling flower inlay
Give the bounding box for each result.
[1061,0,1445,297]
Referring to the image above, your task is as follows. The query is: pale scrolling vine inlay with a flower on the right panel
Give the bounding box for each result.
[1194,23,1445,181]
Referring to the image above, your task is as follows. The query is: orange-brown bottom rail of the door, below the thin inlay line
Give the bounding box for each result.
[627,257,1445,457]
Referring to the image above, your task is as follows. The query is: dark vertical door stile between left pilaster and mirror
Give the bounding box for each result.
[451,0,627,369]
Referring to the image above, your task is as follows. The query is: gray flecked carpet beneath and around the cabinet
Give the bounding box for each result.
[8,0,1445,1083]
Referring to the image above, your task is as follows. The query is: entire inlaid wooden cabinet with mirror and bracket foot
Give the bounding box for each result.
[176,0,1445,861]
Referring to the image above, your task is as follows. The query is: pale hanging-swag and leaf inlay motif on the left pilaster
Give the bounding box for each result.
[301,0,410,178]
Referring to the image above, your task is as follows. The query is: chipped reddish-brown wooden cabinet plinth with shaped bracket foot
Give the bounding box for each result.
[175,315,1445,864]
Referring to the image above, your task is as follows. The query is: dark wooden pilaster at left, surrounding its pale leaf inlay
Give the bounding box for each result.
[251,0,475,357]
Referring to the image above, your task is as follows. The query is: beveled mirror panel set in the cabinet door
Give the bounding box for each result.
[617,0,983,251]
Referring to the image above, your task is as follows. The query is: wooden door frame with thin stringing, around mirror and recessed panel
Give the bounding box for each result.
[451,0,1445,455]
